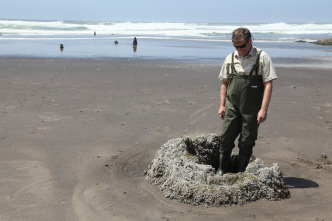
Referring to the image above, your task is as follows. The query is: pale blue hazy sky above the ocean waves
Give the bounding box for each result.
[0,0,332,23]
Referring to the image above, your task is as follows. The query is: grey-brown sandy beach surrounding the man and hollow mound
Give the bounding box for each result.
[0,58,332,221]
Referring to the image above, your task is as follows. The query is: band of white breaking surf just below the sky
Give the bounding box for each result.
[0,20,332,39]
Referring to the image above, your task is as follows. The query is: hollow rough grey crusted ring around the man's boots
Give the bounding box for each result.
[146,134,290,206]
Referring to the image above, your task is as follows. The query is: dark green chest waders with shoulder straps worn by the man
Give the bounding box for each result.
[216,51,264,176]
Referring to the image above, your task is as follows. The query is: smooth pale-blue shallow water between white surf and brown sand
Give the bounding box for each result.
[0,36,332,62]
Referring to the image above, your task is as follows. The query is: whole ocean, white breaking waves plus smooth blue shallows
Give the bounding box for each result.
[0,20,332,62]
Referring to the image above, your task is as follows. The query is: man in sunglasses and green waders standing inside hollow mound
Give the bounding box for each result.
[217,28,278,176]
